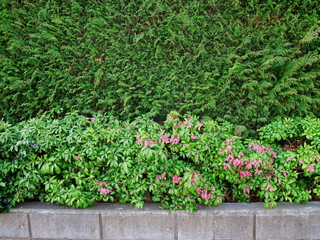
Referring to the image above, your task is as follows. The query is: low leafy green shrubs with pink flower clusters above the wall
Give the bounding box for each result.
[0,112,320,211]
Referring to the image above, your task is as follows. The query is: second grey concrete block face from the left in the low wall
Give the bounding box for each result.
[30,212,100,239]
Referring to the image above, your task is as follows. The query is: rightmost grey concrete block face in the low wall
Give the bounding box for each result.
[256,213,320,240]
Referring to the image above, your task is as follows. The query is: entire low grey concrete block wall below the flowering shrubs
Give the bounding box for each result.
[0,202,320,240]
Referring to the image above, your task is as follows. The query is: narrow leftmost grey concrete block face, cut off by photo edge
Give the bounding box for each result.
[0,213,30,238]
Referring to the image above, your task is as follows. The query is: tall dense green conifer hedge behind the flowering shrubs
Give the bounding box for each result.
[0,0,320,125]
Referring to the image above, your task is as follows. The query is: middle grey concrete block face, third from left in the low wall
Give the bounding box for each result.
[102,213,174,240]
